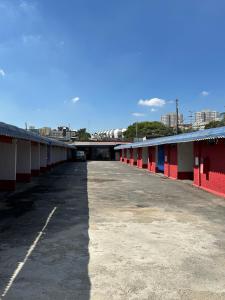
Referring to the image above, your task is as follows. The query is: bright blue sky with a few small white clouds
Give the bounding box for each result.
[0,0,225,131]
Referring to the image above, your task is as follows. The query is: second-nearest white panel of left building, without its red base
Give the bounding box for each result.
[16,140,31,174]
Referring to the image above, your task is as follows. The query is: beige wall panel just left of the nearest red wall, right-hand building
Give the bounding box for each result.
[177,142,194,172]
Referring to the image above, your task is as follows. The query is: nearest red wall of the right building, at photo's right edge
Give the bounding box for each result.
[194,139,225,197]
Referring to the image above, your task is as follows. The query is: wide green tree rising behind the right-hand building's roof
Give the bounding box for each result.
[124,121,174,140]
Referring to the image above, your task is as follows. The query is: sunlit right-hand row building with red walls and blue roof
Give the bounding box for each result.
[115,127,225,197]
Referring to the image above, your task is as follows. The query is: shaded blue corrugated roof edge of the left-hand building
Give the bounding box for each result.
[0,122,74,148]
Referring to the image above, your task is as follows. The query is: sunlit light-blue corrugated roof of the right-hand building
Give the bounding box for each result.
[114,126,225,150]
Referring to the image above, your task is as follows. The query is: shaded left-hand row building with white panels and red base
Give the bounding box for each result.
[0,122,74,190]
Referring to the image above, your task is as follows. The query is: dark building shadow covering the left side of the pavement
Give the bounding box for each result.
[0,162,91,300]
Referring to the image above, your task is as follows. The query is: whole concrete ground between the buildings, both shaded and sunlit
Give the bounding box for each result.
[0,162,225,300]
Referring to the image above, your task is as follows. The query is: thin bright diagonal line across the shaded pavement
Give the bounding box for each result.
[0,207,57,300]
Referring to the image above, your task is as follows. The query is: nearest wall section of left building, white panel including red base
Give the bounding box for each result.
[0,136,17,190]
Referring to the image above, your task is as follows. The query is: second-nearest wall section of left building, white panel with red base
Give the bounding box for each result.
[16,140,31,182]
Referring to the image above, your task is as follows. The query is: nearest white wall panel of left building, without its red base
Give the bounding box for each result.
[0,139,17,180]
